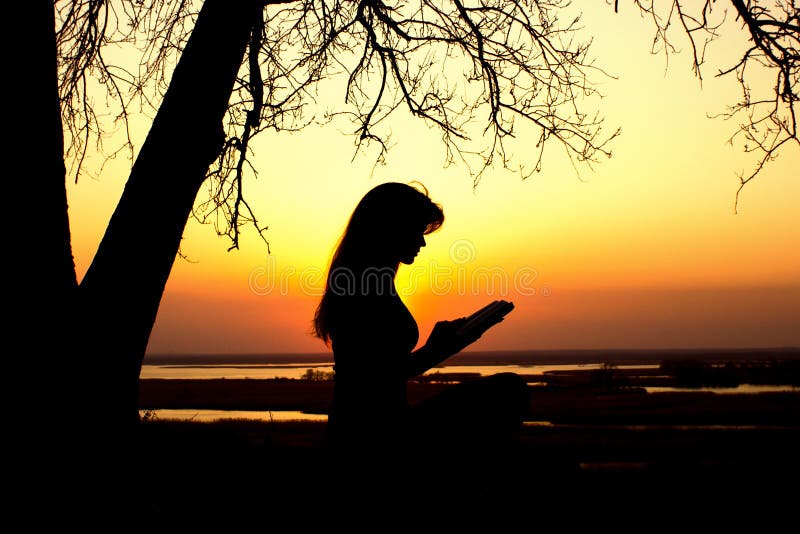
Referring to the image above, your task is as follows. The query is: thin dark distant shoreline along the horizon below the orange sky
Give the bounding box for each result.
[144,347,800,366]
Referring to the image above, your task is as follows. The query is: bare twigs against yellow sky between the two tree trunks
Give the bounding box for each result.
[55,0,198,180]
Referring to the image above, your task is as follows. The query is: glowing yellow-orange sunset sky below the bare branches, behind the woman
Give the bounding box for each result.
[68,5,800,353]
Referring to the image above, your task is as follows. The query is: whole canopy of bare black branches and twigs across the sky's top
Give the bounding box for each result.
[61,0,800,248]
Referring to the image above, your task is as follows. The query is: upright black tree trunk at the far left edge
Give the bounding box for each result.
[10,1,77,518]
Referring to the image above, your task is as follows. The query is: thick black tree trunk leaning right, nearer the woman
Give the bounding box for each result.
[78,0,260,427]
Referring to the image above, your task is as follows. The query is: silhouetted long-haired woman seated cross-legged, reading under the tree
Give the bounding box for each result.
[314,183,528,460]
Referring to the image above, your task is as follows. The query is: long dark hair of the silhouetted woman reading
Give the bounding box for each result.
[313,182,444,345]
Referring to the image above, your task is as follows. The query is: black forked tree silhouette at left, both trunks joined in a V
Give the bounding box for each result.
[12,0,261,524]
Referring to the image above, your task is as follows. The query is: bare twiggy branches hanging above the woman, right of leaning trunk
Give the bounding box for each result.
[195,0,619,248]
